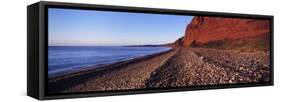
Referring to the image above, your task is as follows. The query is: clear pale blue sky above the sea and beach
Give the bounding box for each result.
[48,8,193,46]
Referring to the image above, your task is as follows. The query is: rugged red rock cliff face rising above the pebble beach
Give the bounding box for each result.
[183,16,270,47]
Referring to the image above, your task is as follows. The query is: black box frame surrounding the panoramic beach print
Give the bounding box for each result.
[27,1,274,100]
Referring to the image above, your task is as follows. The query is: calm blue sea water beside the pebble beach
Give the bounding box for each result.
[48,46,171,76]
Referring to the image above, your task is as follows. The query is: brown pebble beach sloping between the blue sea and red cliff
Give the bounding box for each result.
[48,47,270,93]
